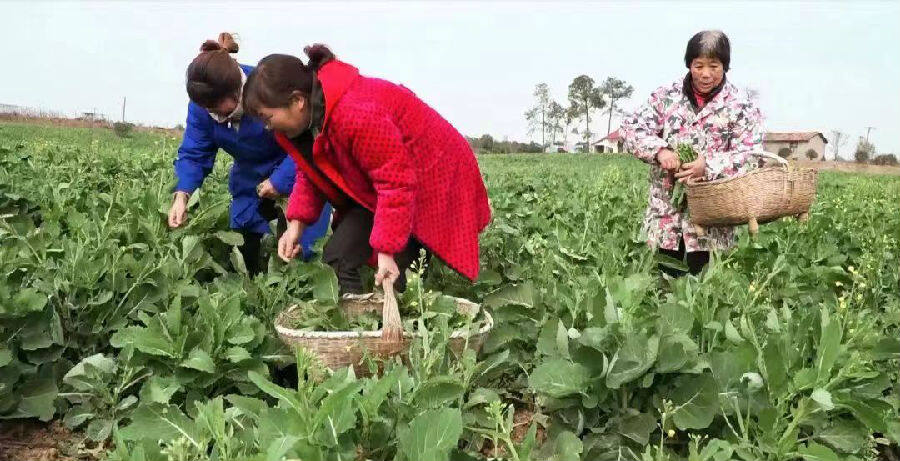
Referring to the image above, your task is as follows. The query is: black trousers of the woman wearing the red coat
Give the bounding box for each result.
[322,206,422,295]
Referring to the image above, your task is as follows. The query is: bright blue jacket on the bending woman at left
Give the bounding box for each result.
[174,65,331,254]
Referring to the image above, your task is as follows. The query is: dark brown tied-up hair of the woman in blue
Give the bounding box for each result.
[186,32,242,107]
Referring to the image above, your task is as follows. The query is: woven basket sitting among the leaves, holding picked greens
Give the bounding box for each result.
[275,286,494,375]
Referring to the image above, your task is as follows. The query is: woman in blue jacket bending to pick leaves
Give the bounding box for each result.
[169,33,331,275]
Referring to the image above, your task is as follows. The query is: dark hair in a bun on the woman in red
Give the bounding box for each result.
[243,44,335,115]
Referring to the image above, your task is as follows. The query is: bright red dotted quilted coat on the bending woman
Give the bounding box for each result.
[276,61,491,281]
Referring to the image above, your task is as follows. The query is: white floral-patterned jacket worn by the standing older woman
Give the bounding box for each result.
[621,80,763,252]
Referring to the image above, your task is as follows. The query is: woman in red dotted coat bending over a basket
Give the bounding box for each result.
[244,45,490,293]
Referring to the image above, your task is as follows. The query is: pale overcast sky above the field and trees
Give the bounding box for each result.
[0,0,900,154]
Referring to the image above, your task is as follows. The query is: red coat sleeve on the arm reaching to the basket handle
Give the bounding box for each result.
[332,105,416,254]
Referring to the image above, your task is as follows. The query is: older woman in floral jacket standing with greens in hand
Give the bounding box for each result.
[621,31,762,276]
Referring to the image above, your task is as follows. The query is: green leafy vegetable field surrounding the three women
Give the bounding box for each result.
[0,124,900,461]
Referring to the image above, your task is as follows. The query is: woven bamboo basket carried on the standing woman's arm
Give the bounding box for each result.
[686,151,818,236]
